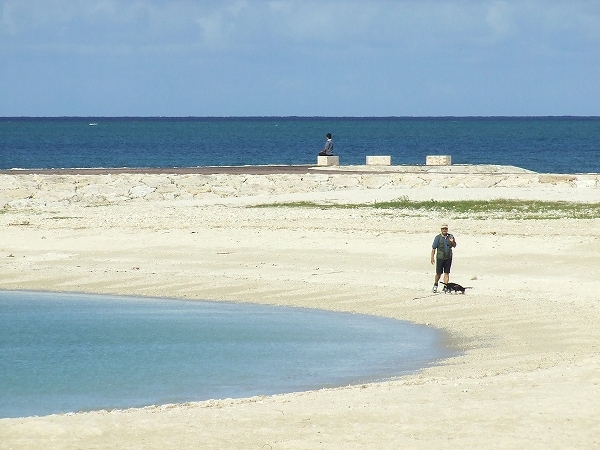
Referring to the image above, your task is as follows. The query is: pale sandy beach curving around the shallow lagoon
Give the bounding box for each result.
[0,166,600,450]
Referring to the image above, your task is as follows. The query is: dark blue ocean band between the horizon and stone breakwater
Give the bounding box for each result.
[0,117,600,173]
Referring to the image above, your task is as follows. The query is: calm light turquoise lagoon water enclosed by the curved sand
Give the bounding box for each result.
[0,291,452,418]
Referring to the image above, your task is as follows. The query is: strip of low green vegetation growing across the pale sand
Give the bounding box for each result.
[255,198,600,220]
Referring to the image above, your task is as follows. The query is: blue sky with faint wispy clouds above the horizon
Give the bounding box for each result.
[0,0,600,117]
